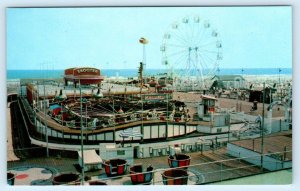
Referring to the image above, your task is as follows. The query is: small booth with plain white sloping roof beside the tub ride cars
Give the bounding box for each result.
[78,150,103,171]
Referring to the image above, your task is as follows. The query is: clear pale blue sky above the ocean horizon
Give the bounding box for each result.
[6,6,292,70]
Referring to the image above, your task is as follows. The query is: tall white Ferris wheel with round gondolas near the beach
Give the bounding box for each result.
[160,16,222,88]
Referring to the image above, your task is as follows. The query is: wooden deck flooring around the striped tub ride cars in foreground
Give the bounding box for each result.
[8,148,260,185]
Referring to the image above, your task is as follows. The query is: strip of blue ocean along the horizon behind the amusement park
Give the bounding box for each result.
[6,68,293,79]
